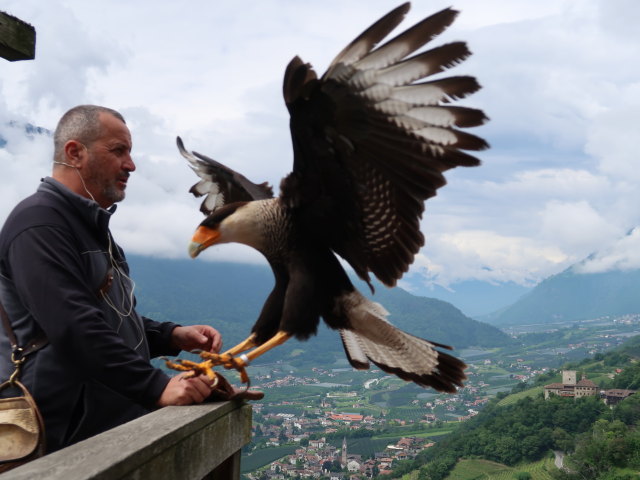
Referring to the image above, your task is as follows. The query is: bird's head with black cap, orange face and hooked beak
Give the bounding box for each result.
[189,202,263,258]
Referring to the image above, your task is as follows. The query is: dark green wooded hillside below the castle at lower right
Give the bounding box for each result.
[379,337,640,480]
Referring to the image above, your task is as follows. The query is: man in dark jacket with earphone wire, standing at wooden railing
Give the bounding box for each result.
[0,105,221,451]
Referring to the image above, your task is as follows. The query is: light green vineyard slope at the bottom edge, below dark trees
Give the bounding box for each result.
[447,458,555,480]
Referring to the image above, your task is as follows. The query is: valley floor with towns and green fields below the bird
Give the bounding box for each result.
[194,316,640,478]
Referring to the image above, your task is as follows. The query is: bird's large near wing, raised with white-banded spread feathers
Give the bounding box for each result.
[281,3,488,285]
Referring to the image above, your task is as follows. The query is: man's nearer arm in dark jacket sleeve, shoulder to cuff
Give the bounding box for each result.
[8,226,170,407]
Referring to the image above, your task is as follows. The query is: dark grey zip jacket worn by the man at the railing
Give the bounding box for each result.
[0,178,177,451]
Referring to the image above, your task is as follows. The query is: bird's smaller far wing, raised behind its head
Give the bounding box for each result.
[176,137,273,215]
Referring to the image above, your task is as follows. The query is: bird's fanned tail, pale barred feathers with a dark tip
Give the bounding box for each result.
[340,292,466,393]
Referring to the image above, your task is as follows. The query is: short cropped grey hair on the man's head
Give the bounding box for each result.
[53,105,127,162]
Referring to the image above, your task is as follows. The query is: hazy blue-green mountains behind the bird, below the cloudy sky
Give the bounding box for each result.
[116,235,640,352]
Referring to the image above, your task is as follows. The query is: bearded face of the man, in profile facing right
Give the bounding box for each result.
[82,113,136,208]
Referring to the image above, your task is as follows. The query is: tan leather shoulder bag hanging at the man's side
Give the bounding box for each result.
[0,380,45,472]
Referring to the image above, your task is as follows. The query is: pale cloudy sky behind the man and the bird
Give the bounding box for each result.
[0,0,640,288]
